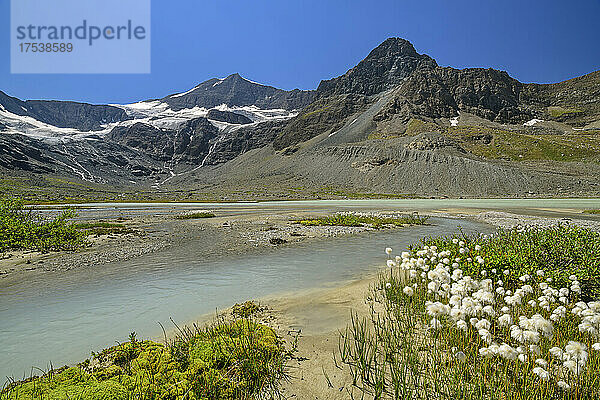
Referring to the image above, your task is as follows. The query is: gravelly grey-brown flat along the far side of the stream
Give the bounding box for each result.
[0,212,408,287]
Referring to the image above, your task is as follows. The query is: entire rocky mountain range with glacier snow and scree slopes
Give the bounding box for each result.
[0,38,600,196]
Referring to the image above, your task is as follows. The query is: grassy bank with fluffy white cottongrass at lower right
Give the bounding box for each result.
[339,226,600,400]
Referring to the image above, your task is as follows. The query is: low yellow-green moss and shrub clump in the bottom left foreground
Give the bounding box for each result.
[0,312,292,400]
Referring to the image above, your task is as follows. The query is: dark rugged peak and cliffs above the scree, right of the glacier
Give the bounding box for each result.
[274,38,600,150]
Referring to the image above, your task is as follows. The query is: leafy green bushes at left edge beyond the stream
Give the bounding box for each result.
[0,198,85,252]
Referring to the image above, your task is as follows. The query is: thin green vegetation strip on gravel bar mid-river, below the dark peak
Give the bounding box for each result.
[296,213,428,229]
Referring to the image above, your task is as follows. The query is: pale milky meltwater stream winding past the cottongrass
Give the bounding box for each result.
[0,218,492,380]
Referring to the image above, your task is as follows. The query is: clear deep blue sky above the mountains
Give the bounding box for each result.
[0,0,600,103]
